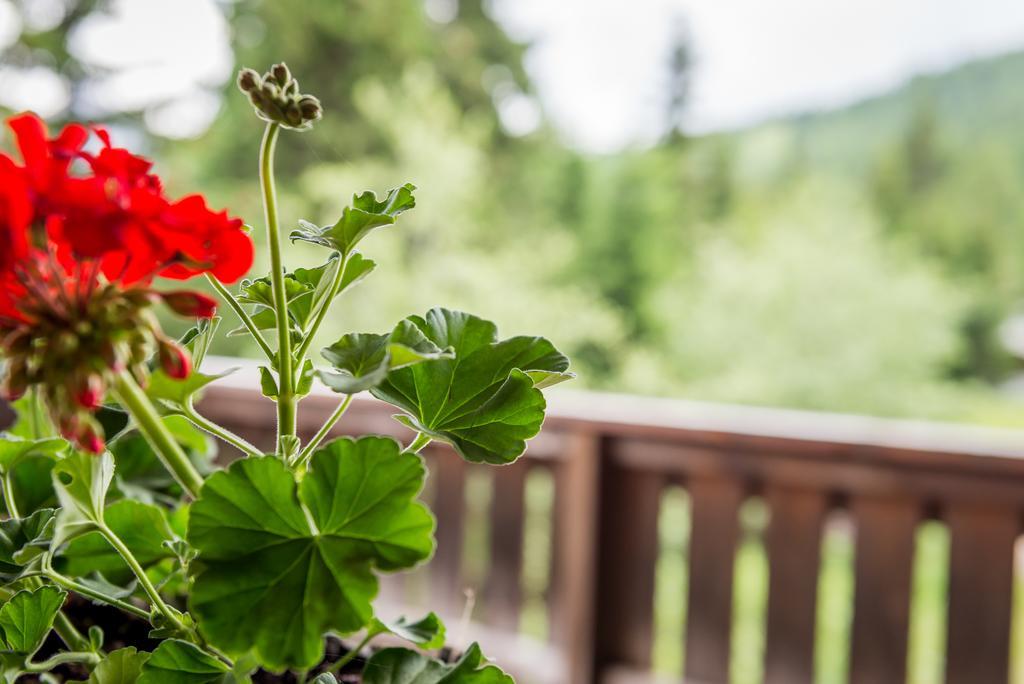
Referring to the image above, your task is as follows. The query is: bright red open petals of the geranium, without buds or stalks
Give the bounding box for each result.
[0,115,253,317]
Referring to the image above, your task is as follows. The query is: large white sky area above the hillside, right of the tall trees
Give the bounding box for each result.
[496,0,1024,152]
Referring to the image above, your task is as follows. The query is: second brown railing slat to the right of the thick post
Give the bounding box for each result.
[685,477,743,684]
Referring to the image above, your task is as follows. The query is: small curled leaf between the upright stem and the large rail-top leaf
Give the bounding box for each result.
[317,320,453,394]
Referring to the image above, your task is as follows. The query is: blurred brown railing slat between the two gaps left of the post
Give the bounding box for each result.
[484,459,529,633]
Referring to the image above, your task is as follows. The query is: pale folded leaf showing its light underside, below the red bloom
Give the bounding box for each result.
[52,452,114,545]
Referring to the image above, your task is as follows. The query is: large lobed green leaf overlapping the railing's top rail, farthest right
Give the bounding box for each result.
[371,308,572,464]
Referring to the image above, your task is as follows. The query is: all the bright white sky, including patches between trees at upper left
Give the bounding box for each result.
[0,0,1024,152]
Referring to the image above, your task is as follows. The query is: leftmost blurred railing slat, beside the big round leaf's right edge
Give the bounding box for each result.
[430,450,466,616]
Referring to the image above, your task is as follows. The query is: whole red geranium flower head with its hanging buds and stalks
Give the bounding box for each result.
[0,114,253,448]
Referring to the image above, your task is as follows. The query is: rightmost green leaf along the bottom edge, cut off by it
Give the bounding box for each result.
[362,644,515,684]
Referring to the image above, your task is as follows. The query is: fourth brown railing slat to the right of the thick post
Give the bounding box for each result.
[850,498,921,684]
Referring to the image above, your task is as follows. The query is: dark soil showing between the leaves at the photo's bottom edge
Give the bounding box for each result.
[28,594,364,684]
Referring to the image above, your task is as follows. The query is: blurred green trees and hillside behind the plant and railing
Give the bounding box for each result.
[5,0,1024,424]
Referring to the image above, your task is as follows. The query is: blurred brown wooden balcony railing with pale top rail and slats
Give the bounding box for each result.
[9,359,1024,684]
